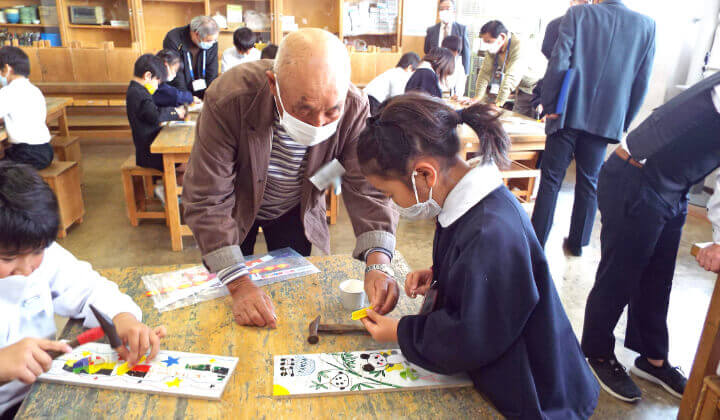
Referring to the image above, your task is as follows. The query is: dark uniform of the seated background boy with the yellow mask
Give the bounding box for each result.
[125,80,180,171]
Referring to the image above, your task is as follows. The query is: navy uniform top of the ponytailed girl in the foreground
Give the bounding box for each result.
[398,166,599,420]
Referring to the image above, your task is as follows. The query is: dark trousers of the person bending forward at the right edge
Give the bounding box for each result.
[582,154,687,359]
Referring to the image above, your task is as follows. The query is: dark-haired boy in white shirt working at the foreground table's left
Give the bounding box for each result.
[0,161,165,418]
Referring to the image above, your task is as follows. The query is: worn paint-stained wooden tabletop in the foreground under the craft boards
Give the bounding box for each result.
[18,255,501,420]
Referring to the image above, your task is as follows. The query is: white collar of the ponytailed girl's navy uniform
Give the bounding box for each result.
[438,163,503,228]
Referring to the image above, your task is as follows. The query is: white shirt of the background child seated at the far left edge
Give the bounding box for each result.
[0,77,50,144]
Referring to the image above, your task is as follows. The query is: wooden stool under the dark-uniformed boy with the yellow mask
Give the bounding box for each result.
[121,155,168,226]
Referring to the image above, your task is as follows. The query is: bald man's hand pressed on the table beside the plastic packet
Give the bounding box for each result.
[227,276,277,328]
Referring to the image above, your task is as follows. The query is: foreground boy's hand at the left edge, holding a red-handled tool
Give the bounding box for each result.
[0,338,72,384]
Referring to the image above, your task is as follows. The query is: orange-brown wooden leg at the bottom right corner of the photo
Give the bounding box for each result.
[678,278,720,420]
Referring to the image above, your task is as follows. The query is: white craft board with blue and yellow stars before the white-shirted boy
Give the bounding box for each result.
[38,343,238,400]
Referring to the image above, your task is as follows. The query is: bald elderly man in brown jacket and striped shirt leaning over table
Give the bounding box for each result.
[182,29,398,327]
